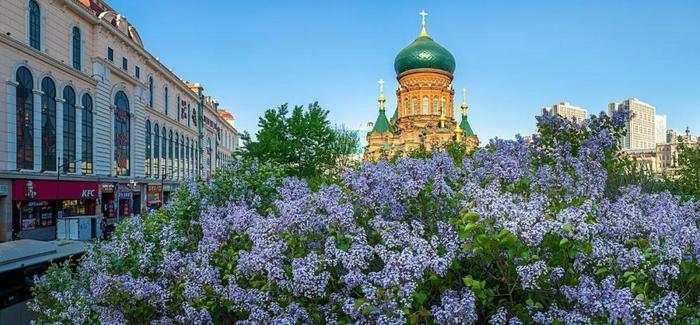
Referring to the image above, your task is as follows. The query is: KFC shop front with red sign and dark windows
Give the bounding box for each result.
[12,179,98,240]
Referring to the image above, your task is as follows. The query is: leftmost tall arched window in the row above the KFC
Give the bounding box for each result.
[15,67,34,169]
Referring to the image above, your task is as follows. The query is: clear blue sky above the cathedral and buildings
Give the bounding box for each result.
[109,0,700,141]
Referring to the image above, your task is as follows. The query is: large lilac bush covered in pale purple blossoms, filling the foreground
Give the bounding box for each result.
[31,112,700,324]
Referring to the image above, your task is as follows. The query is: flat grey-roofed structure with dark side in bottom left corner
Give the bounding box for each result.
[0,239,86,324]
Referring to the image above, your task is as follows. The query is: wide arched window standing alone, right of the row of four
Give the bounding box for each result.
[114,91,131,176]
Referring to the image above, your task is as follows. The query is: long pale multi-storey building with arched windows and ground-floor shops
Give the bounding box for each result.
[0,0,238,241]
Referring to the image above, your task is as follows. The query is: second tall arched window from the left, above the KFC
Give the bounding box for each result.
[41,77,56,171]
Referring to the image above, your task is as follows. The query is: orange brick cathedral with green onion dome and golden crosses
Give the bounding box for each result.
[364,12,479,160]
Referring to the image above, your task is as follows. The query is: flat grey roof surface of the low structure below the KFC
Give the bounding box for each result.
[0,239,85,272]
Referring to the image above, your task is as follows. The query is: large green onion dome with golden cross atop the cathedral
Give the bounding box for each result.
[394,11,455,75]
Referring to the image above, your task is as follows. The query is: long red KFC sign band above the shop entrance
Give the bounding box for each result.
[12,179,98,201]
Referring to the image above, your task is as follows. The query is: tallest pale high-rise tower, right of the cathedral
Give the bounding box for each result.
[608,98,656,150]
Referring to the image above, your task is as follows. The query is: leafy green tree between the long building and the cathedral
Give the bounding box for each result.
[241,102,358,182]
